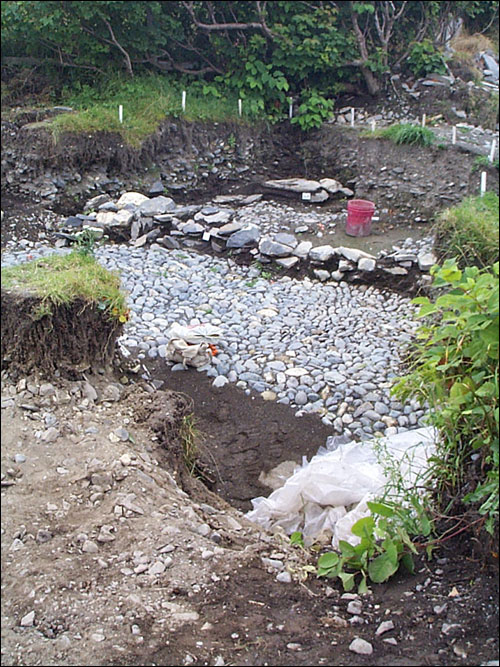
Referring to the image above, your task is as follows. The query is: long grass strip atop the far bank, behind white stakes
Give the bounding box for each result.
[51,75,249,146]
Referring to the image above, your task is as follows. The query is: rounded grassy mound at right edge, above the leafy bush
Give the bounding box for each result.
[434,192,499,268]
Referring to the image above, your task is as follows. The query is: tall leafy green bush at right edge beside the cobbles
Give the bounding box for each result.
[394,260,499,533]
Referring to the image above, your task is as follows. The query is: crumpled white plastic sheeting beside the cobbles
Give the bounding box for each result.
[246,427,437,548]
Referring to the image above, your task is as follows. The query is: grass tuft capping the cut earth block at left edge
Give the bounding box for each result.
[1,251,128,322]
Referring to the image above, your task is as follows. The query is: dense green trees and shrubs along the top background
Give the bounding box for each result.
[1,0,498,108]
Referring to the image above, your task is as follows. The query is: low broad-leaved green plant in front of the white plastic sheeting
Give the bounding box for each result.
[317,501,431,594]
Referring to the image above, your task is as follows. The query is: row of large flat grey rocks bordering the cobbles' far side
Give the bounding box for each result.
[59,189,436,284]
